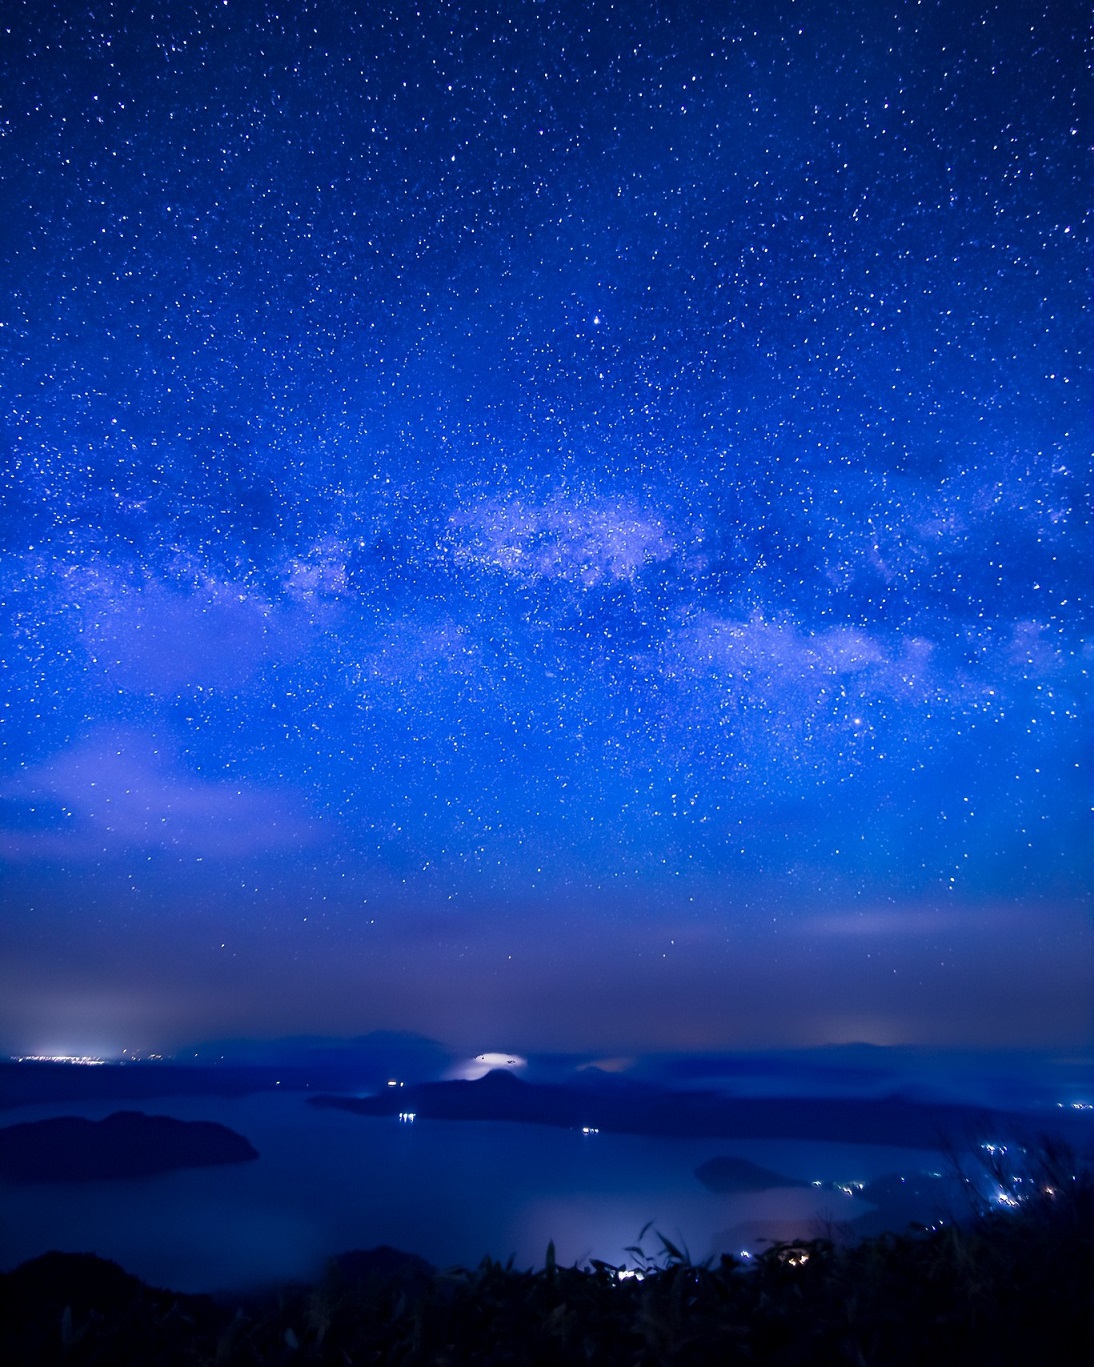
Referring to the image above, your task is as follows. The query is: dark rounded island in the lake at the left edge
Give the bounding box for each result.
[0,1111,258,1182]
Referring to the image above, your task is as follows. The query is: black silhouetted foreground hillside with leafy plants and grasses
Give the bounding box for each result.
[0,1153,1094,1367]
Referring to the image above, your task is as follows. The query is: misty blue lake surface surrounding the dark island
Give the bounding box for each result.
[0,1092,942,1292]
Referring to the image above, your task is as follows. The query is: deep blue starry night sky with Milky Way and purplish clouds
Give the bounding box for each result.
[0,0,1094,1054]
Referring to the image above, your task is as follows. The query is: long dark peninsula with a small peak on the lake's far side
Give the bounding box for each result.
[309,1069,1086,1148]
